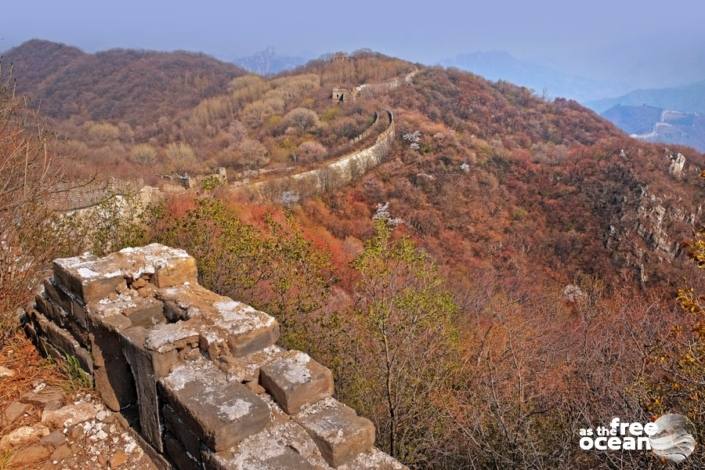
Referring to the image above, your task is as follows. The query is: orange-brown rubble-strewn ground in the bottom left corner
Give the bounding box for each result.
[0,338,157,470]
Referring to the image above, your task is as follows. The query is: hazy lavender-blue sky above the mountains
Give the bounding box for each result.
[0,0,705,86]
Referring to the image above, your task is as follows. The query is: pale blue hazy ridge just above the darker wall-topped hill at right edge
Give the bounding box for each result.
[587,80,705,113]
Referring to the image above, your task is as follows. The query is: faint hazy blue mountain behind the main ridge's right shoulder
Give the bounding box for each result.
[441,51,628,102]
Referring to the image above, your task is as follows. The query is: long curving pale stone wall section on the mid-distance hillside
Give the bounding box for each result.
[238,111,396,204]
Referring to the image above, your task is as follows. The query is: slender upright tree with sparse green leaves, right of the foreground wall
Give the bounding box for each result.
[339,221,457,464]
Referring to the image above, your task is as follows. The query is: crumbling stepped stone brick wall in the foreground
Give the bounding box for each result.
[25,244,403,470]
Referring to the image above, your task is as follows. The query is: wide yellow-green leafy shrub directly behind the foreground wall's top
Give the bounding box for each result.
[149,199,332,352]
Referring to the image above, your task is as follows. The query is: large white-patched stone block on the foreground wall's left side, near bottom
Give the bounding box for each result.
[159,359,269,452]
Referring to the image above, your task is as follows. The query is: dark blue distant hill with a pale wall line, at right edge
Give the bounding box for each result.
[602,105,705,152]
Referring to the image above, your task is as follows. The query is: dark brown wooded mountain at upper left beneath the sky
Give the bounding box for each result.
[3,39,244,124]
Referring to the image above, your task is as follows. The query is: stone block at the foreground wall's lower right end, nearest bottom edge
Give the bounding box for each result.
[295,398,375,467]
